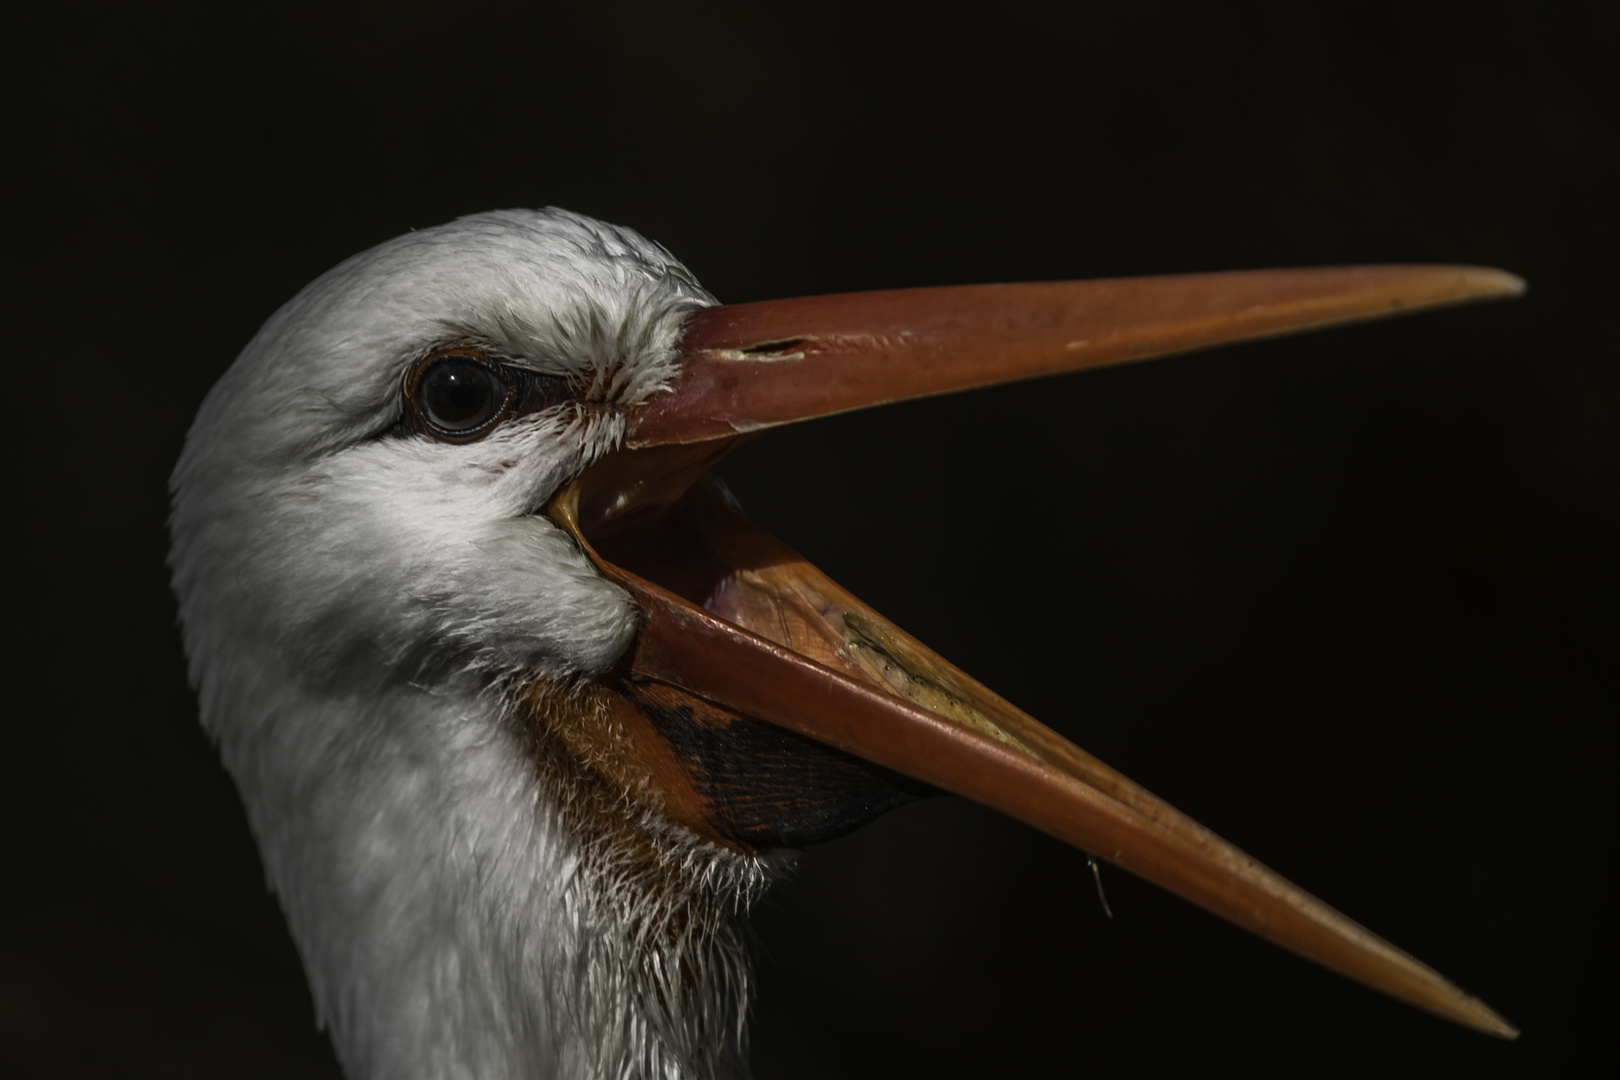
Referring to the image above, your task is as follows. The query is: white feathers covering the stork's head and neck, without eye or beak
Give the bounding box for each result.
[170,210,766,1080]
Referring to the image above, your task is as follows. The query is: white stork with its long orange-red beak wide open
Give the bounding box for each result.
[170,209,1523,1080]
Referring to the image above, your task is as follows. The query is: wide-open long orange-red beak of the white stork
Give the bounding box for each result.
[548,267,1523,1038]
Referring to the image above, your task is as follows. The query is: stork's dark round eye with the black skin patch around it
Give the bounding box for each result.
[400,348,573,442]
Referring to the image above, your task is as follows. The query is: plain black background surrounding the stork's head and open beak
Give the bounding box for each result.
[0,2,1620,1080]
